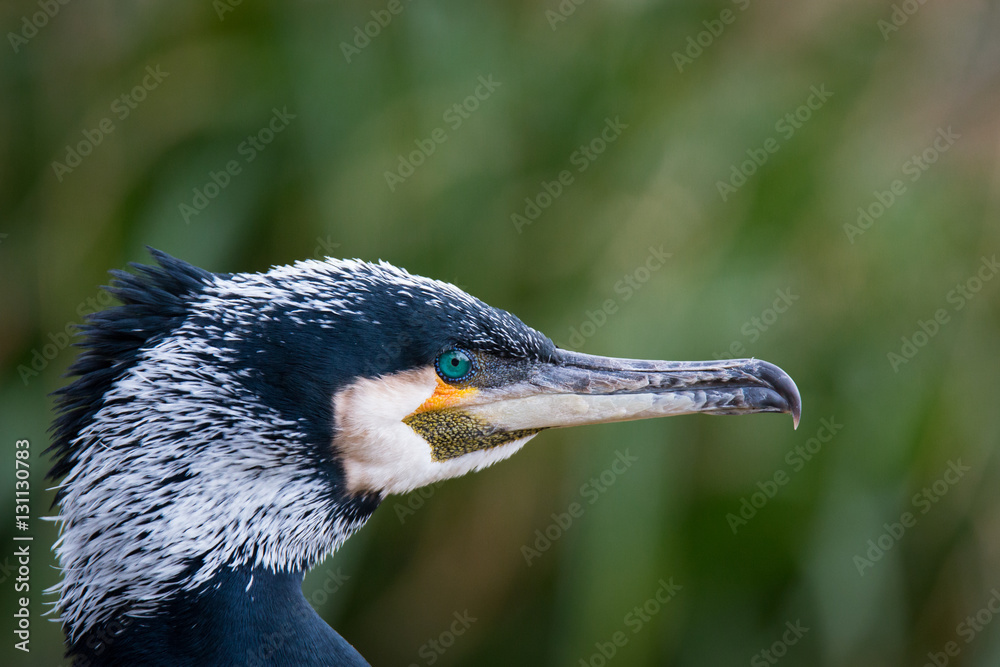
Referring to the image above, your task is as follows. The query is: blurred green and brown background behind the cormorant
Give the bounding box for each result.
[0,0,1000,667]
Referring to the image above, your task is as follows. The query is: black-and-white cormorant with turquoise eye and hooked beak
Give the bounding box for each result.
[50,249,800,667]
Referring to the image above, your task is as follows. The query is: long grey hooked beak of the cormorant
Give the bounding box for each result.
[462,350,802,431]
